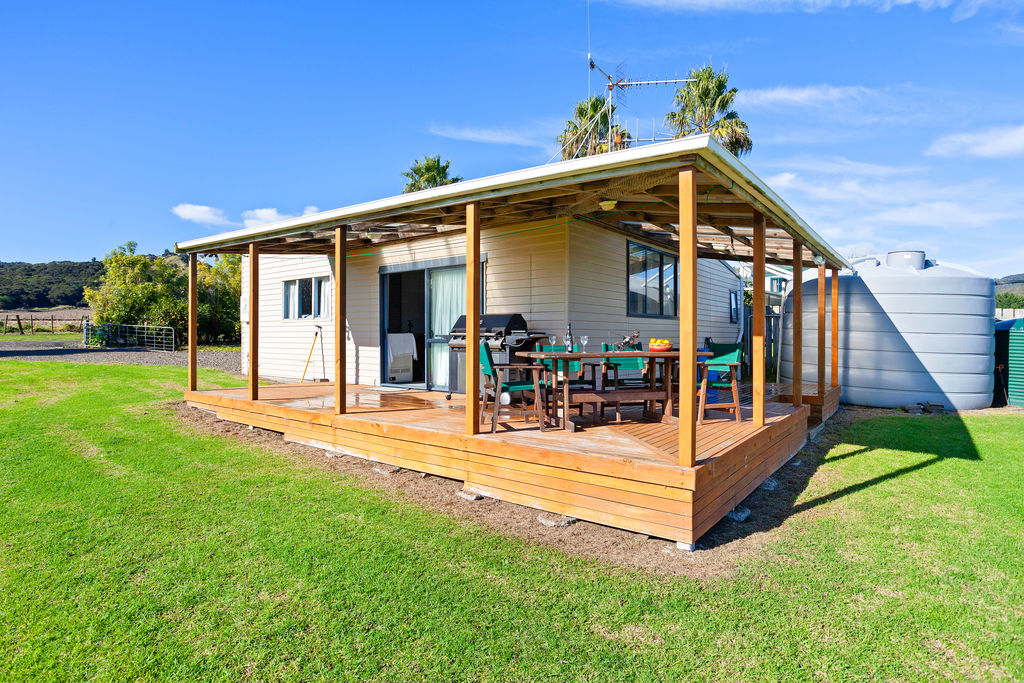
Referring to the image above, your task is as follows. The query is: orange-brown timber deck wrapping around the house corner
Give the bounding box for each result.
[185,383,809,543]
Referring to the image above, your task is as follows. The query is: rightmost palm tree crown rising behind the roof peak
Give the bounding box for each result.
[665,65,754,157]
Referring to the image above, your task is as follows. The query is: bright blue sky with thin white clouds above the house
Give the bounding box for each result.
[0,0,1024,276]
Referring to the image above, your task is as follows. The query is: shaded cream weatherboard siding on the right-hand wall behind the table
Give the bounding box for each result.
[559,223,742,350]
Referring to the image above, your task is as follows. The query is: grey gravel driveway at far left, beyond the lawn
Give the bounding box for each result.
[0,341,242,375]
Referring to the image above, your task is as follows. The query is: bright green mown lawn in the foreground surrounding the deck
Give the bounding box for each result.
[0,361,1024,681]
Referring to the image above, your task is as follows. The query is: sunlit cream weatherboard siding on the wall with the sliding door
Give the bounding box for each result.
[242,219,567,385]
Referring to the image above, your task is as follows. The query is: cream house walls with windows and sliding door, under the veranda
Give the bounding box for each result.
[235,248,742,393]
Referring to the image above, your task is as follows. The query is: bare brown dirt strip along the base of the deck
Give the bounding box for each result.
[174,401,893,579]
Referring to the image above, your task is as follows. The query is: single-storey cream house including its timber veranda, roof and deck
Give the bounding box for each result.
[176,135,856,549]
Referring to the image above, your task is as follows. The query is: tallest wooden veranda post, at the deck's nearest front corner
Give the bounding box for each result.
[679,168,697,467]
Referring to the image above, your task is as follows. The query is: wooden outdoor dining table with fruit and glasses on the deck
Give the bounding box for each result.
[517,350,712,431]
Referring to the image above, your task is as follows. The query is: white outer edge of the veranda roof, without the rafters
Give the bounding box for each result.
[174,135,850,267]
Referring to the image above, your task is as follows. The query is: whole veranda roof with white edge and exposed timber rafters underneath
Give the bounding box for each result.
[175,135,849,267]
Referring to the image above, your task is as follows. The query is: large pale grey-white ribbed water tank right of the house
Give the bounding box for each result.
[780,251,995,411]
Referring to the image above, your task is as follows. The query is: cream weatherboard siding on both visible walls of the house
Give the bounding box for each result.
[242,219,741,385]
